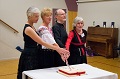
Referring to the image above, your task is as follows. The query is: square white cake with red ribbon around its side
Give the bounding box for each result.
[58,66,85,77]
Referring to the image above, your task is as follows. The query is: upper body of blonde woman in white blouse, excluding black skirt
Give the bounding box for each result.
[38,8,58,49]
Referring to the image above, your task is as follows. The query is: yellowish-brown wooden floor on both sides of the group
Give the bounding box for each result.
[0,56,120,79]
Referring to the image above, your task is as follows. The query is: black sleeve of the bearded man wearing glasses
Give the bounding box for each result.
[52,26,65,48]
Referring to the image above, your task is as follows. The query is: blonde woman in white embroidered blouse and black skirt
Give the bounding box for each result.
[38,8,58,68]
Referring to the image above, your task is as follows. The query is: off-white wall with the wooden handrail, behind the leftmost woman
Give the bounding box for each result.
[0,0,67,59]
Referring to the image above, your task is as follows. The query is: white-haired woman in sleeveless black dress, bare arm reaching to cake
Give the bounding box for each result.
[17,7,69,79]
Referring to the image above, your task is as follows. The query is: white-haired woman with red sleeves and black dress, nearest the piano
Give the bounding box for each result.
[66,16,87,65]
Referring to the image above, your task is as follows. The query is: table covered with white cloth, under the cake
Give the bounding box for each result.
[22,64,118,79]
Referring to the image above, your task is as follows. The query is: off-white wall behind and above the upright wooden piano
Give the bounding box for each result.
[78,0,120,42]
